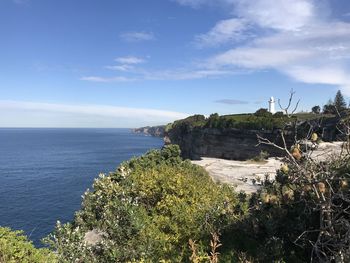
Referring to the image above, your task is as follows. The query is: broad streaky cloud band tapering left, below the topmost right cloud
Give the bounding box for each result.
[208,21,350,95]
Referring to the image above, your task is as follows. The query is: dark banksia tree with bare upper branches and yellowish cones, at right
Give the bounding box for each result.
[254,92,350,263]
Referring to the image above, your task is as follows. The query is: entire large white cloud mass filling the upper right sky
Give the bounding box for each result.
[176,0,350,95]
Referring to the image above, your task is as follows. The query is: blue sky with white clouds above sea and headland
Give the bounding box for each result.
[0,0,350,127]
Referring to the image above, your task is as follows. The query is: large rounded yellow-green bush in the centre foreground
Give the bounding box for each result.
[48,146,246,262]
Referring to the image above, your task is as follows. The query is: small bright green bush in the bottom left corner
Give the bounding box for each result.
[0,227,57,263]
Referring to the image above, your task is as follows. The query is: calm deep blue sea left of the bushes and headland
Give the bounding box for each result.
[0,129,163,249]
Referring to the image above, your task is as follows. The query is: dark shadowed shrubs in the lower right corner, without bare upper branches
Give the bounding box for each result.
[222,152,350,262]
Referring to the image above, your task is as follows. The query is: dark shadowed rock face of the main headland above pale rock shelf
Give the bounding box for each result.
[165,128,292,160]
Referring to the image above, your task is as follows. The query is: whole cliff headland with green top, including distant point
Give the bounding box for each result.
[134,114,342,160]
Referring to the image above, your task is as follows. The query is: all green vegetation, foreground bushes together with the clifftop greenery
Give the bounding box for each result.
[4,91,350,263]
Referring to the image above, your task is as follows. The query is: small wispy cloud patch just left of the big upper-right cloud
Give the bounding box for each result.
[196,18,248,47]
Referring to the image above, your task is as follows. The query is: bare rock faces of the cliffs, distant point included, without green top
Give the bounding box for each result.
[134,118,341,160]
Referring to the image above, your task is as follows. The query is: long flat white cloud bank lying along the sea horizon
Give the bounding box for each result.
[0,101,188,127]
